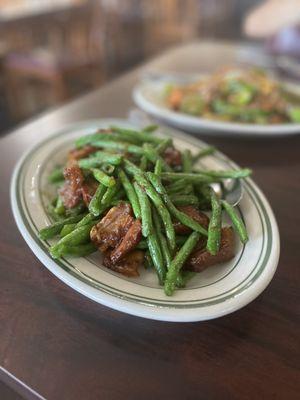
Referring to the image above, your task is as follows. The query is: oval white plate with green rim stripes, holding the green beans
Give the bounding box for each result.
[11,120,279,322]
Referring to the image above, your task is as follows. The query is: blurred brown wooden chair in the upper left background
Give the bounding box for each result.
[4,3,105,119]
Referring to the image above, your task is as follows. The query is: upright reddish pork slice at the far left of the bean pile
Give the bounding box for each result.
[59,160,84,208]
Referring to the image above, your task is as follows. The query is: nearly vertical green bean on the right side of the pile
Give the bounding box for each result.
[206,189,222,256]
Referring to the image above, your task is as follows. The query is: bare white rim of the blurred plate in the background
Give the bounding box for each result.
[133,80,300,136]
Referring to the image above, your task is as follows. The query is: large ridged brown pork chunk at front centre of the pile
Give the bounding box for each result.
[91,202,134,252]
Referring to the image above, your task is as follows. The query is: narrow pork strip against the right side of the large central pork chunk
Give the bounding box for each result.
[110,219,142,264]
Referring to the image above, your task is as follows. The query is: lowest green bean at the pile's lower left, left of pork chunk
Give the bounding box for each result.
[50,221,97,258]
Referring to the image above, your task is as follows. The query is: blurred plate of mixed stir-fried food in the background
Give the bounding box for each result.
[133,69,300,136]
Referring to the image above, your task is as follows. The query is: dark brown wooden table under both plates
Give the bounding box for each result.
[0,43,300,400]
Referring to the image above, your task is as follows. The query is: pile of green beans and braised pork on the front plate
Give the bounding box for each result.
[40,126,251,296]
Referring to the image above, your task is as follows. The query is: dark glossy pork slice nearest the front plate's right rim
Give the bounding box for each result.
[185,227,235,272]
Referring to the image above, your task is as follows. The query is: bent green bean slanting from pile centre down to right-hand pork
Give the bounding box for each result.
[147,172,207,236]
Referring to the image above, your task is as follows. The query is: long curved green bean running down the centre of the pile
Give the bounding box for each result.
[124,160,176,251]
